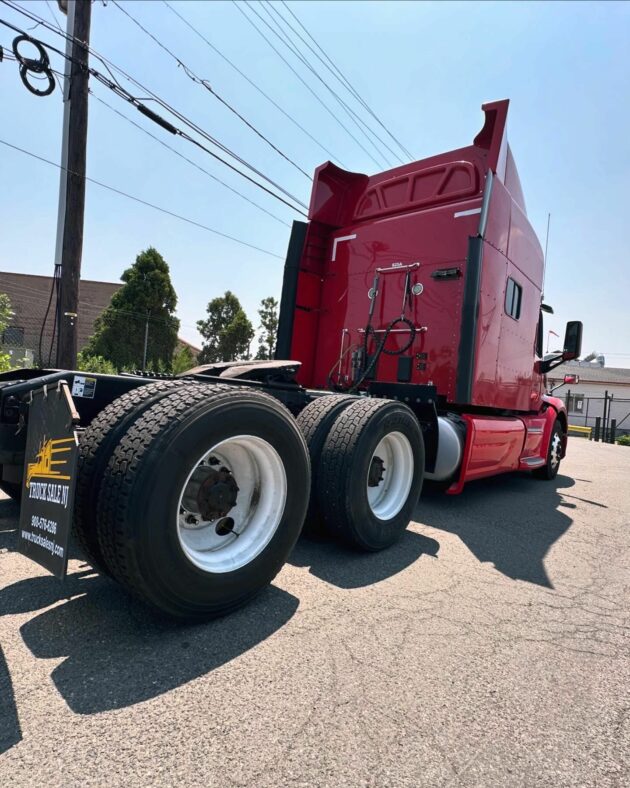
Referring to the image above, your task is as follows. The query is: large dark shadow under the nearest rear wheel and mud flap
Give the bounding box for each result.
[0,571,299,714]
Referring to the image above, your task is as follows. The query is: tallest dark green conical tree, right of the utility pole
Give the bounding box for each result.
[83,247,179,369]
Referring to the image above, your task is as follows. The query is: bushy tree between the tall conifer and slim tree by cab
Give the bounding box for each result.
[197,290,255,364]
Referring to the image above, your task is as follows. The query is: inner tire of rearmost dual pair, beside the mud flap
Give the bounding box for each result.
[72,380,189,574]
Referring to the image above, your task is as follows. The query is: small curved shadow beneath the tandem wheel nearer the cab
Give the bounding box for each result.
[289,531,440,589]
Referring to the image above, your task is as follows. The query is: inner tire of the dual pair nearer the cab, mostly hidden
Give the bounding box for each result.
[297,394,356,539]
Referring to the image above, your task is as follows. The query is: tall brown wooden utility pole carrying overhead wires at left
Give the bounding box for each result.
[55,0,92,369]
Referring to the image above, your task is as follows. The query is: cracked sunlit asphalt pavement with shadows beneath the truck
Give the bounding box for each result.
[0,439,630,788]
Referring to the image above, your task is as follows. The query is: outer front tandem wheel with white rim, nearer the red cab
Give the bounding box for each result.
[317,400,424,551]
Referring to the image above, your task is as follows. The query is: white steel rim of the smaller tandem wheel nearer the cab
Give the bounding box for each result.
[367,432,414,520]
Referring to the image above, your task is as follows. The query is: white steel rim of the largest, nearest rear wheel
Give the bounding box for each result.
[176,435,287,573]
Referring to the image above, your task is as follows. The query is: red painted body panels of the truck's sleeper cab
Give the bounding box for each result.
[291,101,564,492]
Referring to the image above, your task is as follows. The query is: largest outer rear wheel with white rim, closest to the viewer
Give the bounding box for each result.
[98,385,309,618]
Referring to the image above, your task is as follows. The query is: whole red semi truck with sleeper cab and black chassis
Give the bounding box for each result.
[0,101,582,618]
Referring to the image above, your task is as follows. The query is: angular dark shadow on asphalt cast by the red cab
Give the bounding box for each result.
[415,474,575,588]
